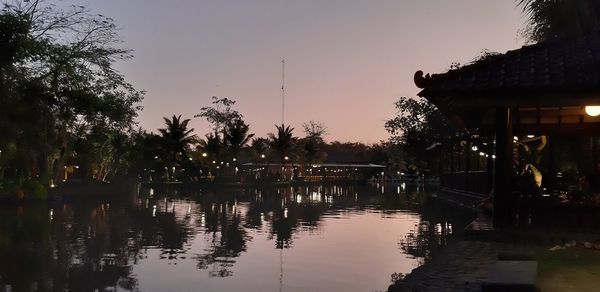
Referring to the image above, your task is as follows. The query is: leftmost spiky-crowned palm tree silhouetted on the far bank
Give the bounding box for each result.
[158,115,198,177]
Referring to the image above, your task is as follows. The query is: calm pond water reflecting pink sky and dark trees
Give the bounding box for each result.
[0,186,468,291]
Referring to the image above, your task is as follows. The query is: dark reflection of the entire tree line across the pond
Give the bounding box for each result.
[0,187,454,291]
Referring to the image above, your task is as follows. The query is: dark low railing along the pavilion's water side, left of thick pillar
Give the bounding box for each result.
[440,171,491,197]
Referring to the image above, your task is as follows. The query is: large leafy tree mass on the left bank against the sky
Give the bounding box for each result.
[0,0,143,190]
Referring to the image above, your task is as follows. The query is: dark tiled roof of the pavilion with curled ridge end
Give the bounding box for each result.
[415,31,600,97]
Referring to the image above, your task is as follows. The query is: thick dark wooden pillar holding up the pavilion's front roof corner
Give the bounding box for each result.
[494,108,518,228]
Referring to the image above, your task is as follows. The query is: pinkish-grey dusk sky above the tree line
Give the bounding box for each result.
[70,0,525,143]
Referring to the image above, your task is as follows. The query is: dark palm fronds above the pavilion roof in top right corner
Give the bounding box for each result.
[516,0,600,42]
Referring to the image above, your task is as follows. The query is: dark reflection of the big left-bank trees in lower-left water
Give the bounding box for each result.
[0,204,137,291]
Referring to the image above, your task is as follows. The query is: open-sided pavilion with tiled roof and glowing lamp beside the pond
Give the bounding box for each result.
[414,31,600,227]
